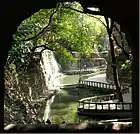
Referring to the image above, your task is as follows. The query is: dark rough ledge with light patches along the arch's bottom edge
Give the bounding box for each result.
[4,122,132,133]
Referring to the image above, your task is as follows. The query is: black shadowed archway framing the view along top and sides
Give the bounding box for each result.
[0,0,139,132]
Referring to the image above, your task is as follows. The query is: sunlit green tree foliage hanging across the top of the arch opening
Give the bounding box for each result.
[7,2,106,70]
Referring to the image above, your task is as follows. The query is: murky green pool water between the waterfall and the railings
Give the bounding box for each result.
[50,75,107,124]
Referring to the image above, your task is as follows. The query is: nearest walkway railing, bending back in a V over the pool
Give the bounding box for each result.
[78,94,132,110]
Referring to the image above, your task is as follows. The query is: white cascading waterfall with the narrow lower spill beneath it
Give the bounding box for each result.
[40,50,60,122]
